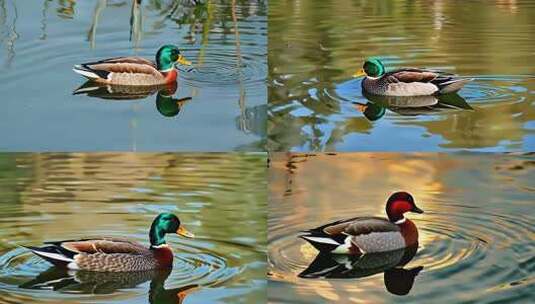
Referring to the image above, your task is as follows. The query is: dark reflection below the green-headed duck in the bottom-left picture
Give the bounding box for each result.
[19,267,199,304]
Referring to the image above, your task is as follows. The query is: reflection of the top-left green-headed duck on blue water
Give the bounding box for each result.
[73,81,191,117]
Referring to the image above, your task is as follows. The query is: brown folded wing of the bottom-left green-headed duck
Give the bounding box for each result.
[47,238,149,254]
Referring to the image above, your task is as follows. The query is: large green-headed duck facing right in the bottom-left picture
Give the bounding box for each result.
[26,213,194,272]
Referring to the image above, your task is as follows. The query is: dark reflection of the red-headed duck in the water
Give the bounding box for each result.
[299,244,424,296]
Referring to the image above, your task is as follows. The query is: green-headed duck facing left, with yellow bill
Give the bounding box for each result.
[353,58,473,96]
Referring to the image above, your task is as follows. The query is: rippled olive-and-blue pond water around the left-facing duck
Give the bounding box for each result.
[268,0,535,151]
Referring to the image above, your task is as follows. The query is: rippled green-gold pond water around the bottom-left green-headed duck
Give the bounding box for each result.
[0,153,267,303]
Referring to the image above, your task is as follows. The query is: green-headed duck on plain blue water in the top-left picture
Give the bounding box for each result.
[73,44,191,86]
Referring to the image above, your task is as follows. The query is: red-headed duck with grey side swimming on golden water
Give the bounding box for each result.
[300,192,423,255]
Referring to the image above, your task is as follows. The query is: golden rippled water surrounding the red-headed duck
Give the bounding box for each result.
[268,153,535,303]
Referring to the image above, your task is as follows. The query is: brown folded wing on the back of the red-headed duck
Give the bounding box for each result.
[325,217,400,236]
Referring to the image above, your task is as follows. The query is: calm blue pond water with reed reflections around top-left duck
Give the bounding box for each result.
[0,0,267,151]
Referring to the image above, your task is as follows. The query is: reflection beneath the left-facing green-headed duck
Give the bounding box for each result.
[354,91,473,121]
